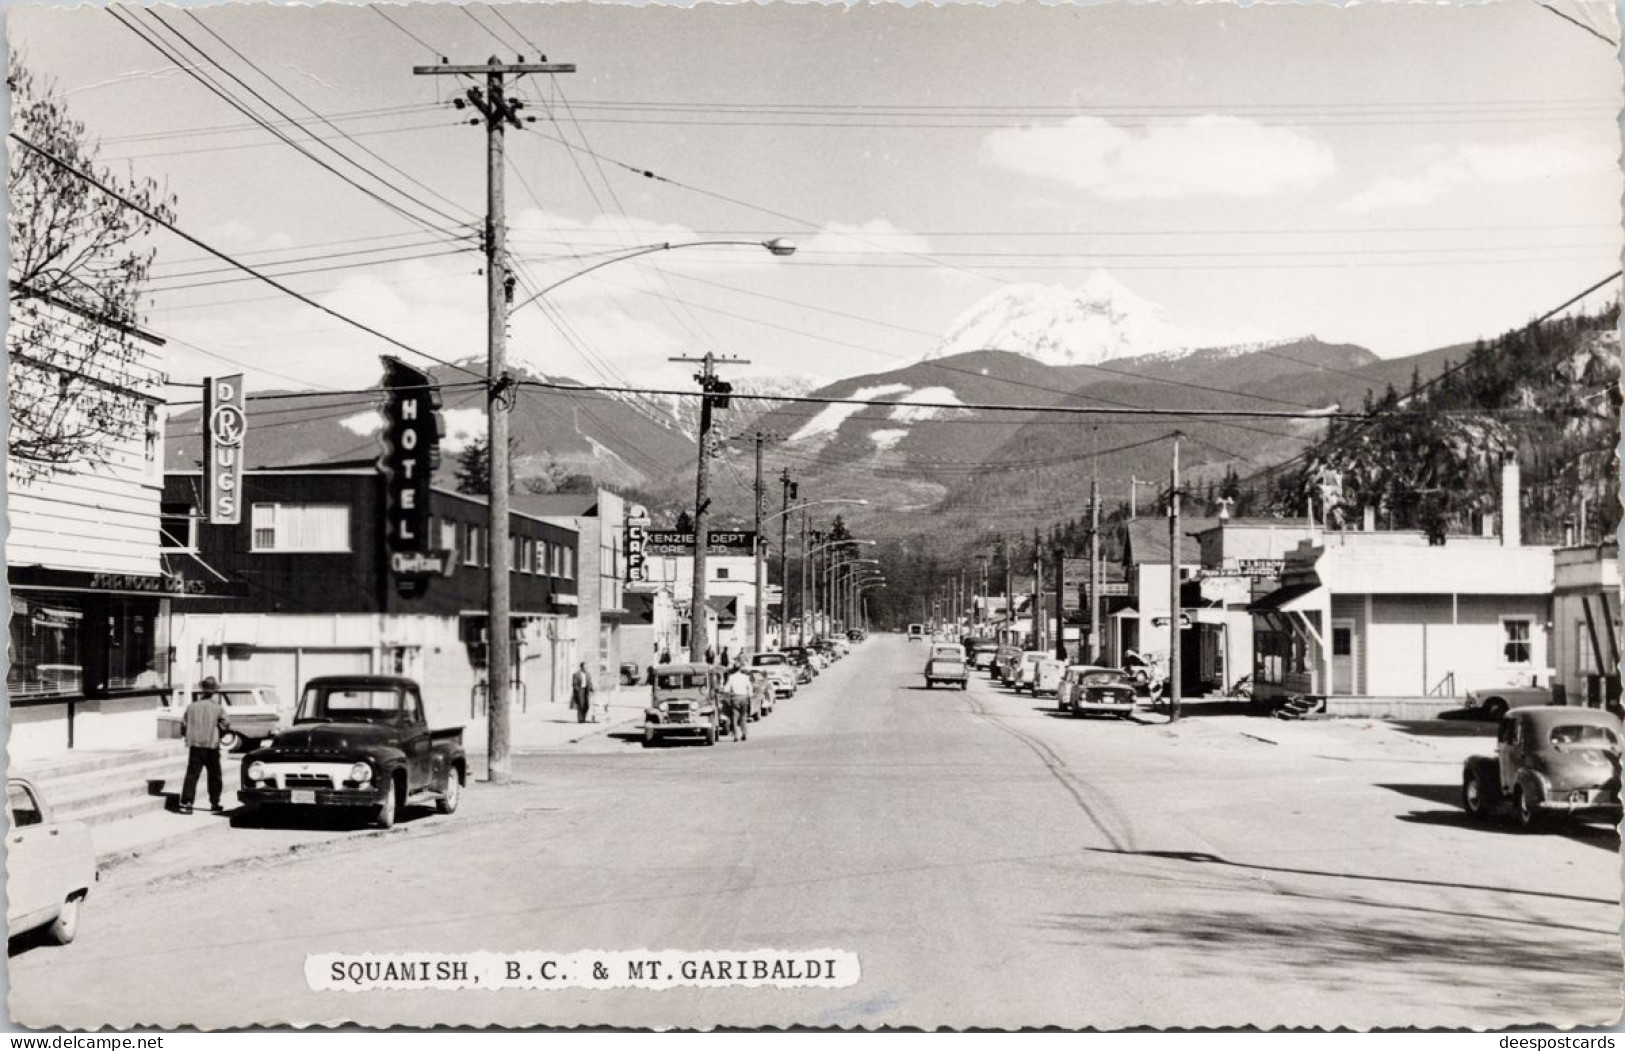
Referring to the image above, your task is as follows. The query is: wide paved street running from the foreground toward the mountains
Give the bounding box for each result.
[11,635,1620,1027]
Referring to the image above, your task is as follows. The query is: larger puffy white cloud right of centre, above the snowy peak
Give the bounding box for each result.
[982,115,1337,200]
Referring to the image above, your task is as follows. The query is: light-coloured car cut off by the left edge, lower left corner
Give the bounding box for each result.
[5,778,96,945]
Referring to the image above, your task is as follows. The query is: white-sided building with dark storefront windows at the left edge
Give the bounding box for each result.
[5,301,229,762]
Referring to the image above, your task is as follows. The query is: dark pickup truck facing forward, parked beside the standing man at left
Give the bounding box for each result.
[237,676,468,828]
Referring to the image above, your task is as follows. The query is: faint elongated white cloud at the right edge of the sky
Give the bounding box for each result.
[1337,135,1614,211]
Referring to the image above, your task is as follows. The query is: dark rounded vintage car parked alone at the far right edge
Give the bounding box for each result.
[1461,705,1620,828]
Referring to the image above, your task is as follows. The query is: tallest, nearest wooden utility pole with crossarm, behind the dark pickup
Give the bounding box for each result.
[413,55,575,785]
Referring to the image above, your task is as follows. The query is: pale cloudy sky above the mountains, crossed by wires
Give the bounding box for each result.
[7,0,1622,388]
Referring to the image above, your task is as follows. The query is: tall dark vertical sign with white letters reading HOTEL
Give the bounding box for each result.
[379,357,452,598]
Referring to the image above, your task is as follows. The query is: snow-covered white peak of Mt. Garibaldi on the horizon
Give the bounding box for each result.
[926,270,1269,365]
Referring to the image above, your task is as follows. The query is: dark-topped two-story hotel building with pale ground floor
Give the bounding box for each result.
[163,460,580,737]
